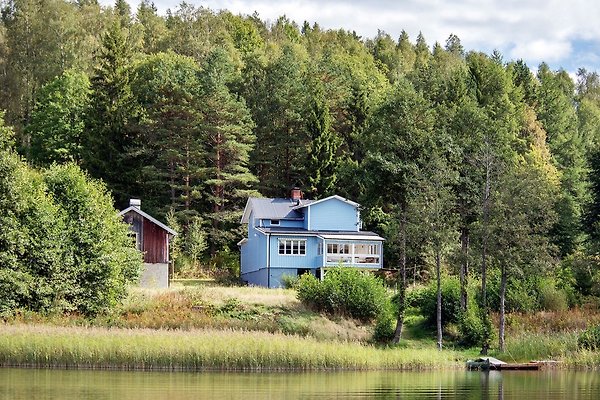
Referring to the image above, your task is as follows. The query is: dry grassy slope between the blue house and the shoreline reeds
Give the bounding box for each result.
[5,286,371,342]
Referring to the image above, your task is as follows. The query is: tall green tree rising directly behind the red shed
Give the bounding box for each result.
[131,53,206,219]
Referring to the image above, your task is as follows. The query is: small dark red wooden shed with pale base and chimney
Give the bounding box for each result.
[119,199,177,287]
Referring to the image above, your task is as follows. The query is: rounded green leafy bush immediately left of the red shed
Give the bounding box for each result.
[44,164,141,315]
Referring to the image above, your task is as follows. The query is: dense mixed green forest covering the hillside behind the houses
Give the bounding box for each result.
[0,0,600,348]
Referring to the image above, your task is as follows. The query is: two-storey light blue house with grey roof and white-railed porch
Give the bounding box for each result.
[238,189,384,288]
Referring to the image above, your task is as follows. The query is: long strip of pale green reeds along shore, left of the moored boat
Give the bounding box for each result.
[0,325,462,371]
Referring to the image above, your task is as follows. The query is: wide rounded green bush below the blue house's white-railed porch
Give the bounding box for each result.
[297,267,389,321]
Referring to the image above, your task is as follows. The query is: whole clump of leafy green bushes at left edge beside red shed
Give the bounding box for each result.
[0,149,142,315]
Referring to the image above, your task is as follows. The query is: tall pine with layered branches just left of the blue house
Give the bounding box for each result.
[200,49,257,256]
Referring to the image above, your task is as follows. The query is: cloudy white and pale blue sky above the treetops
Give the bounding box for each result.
[102,0,600,75]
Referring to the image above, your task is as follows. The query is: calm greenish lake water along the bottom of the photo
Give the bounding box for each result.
[0,368,600,400]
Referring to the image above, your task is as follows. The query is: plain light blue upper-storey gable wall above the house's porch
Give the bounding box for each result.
[304,199,359,232]
